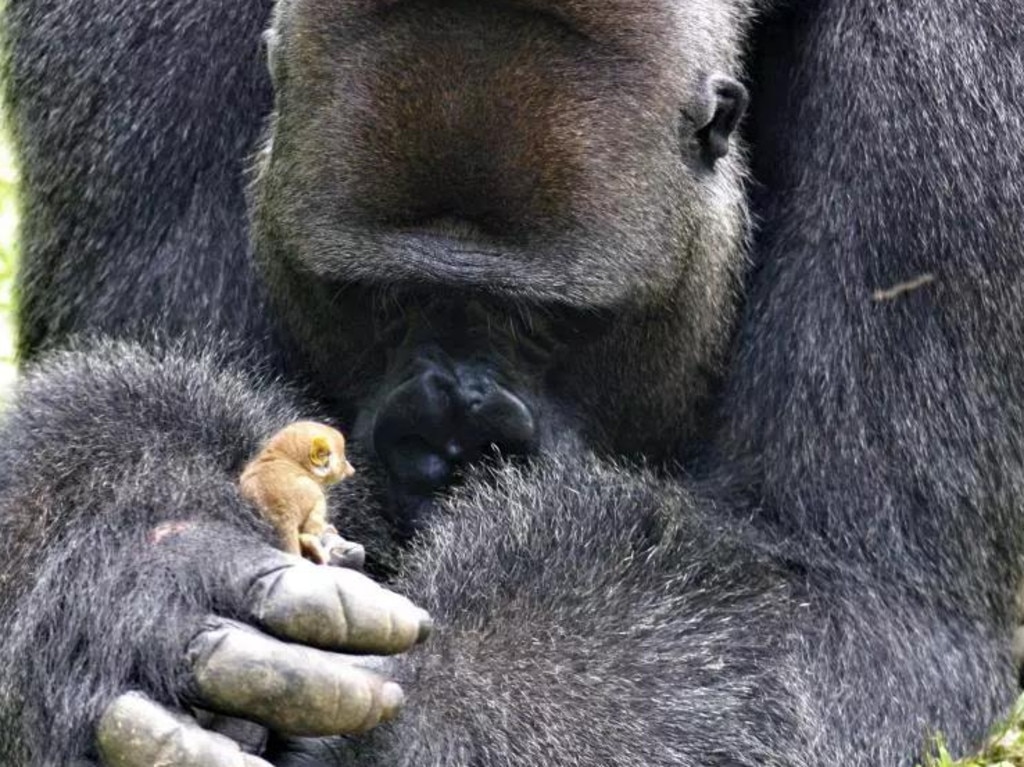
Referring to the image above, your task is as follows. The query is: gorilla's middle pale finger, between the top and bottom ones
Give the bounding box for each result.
[187,614,404,736]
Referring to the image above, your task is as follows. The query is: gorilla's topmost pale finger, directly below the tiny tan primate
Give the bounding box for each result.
[247,559,433,655]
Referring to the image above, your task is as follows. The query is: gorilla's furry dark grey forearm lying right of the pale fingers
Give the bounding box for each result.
[280,456,1013,767]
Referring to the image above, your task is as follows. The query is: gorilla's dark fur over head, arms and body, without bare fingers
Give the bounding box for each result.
[0,0,1024,767]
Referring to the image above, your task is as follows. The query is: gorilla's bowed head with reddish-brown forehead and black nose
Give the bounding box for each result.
[253,0,745,528]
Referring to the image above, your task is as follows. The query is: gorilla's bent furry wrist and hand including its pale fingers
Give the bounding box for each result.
[0,344,429,766]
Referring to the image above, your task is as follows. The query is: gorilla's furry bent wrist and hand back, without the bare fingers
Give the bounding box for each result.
[0,344,295,764]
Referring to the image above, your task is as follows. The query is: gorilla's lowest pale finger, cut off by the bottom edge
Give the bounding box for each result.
[96,692,270,767]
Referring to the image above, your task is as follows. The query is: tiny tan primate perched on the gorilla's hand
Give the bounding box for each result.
[239,421,362,565]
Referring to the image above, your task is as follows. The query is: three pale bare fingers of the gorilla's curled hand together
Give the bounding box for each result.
[97,532,431,767]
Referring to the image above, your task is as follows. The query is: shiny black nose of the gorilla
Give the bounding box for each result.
[373,354,537,528]
